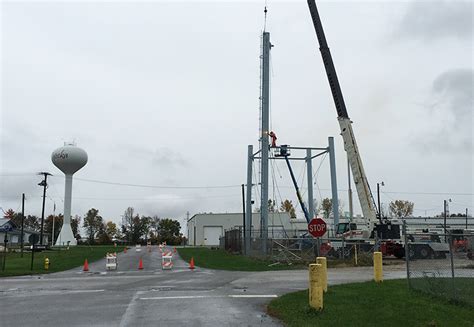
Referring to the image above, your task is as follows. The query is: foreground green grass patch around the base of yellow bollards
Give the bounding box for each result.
[268,280,474,327]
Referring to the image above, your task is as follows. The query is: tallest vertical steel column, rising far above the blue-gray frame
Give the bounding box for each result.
[260,32,271,255]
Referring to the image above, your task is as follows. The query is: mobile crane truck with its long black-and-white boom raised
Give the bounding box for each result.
[308,0,446,258]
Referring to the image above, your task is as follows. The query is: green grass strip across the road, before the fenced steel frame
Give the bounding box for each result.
[177,247,306,271]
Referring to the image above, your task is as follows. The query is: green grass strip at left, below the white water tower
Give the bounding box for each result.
[0,245,123,277]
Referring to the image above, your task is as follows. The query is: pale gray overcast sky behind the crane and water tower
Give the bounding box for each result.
[0,1,474,231]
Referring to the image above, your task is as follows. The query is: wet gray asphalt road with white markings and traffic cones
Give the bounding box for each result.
[0,247,406,327]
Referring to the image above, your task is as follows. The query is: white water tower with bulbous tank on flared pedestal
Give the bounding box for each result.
[51,143,87,245]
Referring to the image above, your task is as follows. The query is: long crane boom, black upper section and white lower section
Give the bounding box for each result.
[308,0,377,230]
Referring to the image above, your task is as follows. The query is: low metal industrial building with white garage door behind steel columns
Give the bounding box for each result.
[187,212,307,246]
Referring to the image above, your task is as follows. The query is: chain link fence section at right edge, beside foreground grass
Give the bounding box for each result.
[405,227,474,306]
